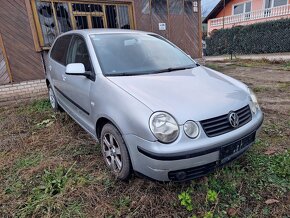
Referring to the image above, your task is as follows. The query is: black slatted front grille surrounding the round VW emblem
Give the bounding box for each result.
[200,105,252,137]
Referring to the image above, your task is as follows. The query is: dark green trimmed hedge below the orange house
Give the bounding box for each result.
[206,19,290,55]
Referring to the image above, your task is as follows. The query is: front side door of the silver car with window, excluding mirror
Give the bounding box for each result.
[64,35,94,132]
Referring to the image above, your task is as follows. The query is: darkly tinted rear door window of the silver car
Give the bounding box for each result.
[50,35,72,65]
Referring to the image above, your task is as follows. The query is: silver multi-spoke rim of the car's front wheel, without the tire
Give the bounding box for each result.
[102,133,122,172]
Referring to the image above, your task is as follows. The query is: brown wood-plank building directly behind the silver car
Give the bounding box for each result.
[0,0,202,84]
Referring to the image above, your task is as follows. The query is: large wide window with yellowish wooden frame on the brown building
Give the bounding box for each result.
[31,0,134,48]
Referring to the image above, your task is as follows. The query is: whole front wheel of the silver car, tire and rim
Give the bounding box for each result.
[100,123,131,181]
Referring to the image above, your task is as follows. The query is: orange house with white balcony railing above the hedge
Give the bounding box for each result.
[203,0,290,34]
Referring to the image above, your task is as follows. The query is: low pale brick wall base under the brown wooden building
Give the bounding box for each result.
[0,80,47,105]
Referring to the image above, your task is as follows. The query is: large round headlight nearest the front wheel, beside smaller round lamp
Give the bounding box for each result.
[149,112,179,143]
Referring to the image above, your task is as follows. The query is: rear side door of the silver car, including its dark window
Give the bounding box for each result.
[48,35,72,106]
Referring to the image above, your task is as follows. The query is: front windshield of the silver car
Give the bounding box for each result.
[91,33,196,76]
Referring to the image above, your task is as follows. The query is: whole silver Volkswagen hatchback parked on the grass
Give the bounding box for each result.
[46,29,263,181]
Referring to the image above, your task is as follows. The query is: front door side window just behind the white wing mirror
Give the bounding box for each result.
[67,36,92,71]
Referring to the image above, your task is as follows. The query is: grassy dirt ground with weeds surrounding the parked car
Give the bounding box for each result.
[0,58,290,218]
